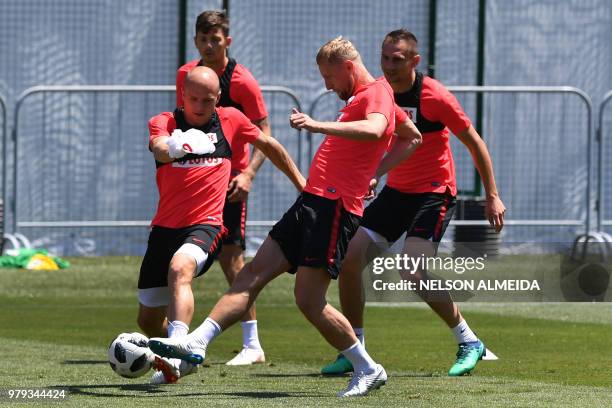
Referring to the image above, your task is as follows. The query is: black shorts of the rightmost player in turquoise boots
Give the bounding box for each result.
[361,186,456,242]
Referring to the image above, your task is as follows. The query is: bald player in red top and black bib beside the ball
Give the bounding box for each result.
[138,67,306,383]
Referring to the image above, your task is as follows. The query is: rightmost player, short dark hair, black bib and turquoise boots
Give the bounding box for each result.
[321,29,506,376]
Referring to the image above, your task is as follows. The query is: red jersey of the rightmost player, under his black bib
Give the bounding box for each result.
[387,76,471,196]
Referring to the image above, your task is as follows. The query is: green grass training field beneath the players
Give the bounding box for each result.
[0,257,612,407]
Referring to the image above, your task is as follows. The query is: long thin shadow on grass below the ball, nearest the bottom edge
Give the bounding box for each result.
[50,384,325,399]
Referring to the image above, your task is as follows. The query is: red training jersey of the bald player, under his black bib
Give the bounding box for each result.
[149,107,260,228]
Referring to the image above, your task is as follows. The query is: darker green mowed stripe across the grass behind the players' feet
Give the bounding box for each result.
[0,299,612,387]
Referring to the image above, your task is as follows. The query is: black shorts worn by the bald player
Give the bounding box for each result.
[138,224,223,289]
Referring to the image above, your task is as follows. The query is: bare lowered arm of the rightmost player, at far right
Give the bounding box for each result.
[457,125,506,232]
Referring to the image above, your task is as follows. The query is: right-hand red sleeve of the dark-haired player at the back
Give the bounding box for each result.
[230,64,268,121]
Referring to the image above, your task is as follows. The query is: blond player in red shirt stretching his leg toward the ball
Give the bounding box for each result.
[149,37,418,397]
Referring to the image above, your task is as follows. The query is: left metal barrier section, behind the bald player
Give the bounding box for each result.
[9,86,304,252]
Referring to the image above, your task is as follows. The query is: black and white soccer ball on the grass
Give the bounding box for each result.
[108,333,155,378]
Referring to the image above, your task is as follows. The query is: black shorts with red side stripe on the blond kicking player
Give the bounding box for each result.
[270,192,361,279]
